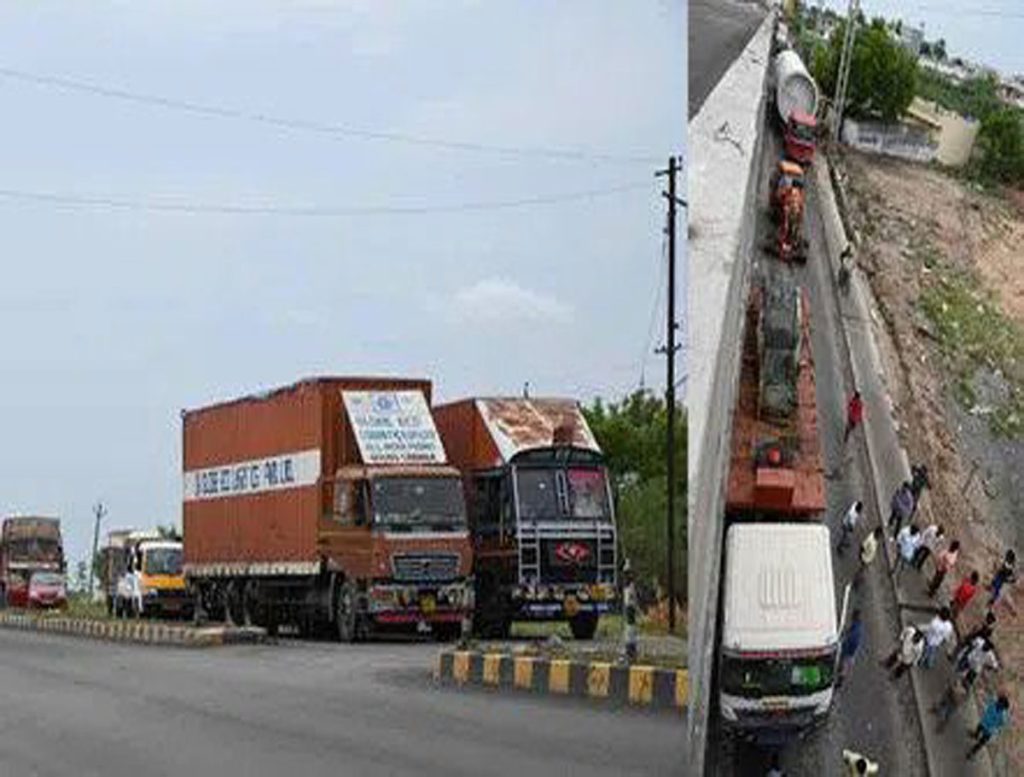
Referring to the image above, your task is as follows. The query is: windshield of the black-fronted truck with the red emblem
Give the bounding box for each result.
[516,467,610,520]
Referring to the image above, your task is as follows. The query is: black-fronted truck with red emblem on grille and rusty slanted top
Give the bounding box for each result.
[434,397,617,639]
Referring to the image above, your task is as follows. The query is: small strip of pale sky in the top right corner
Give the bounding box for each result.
[819,0,1024,75]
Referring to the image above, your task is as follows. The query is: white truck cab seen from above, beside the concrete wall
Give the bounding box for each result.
[718,523,849,743]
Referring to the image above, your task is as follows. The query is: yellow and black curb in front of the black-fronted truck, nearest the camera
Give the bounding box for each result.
[434,650,689,710]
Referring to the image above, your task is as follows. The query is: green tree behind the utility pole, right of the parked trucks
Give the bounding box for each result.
[584,391,686,602]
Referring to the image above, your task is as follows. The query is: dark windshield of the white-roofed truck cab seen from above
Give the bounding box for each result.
[721,652,836,699]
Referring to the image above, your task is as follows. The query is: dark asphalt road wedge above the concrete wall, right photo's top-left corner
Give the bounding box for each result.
[687,0,765,119]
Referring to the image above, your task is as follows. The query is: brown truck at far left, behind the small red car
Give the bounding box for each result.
[0,516,66,606]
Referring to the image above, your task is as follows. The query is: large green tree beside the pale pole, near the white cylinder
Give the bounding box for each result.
[812,18,918,122]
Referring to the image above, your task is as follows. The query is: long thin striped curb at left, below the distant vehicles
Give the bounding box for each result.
[0,612,266,647]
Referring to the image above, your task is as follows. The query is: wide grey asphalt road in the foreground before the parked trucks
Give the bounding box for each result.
[0,630,684,777]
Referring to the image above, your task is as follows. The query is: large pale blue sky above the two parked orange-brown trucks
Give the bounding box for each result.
[0,0,686,565]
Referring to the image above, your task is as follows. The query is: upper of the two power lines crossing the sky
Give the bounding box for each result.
[0,66,655,165]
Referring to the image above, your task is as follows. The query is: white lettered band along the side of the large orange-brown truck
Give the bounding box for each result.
[183,448,321,502]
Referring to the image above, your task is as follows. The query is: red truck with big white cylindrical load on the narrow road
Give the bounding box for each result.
[771,48,818,166]
